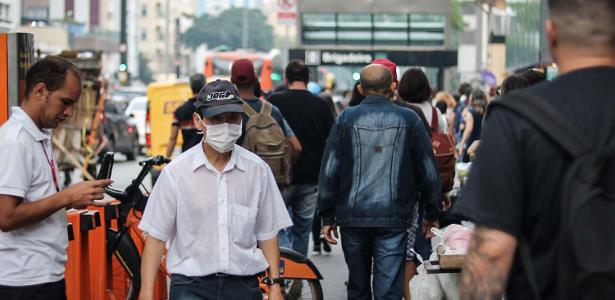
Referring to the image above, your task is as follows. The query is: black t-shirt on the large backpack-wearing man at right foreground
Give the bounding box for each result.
[454,67,615,299]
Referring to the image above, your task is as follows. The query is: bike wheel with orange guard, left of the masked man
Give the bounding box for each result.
[107,229,141,300]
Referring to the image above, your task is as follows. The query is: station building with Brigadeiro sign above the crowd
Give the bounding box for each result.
[289,0,457,90]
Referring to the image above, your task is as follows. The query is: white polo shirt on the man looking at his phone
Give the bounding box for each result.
[0,107,68,286]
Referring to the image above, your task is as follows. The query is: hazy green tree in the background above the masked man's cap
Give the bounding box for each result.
[182,8,274,51]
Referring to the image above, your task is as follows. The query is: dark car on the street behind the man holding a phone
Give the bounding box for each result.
[102,100,140,160]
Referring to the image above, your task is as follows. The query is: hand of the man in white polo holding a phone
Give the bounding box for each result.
[60,179,113,209]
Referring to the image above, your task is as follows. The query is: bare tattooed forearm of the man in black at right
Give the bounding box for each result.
[461,226,517,300]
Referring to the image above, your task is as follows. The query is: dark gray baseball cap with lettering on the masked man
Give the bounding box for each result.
[194,80,243,118]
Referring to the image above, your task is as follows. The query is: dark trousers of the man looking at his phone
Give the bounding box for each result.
[0,279,66,300]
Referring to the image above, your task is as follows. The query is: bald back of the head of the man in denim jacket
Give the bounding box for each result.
[359,64,394,96]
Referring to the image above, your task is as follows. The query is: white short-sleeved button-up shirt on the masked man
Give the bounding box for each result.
[139,144,292,276]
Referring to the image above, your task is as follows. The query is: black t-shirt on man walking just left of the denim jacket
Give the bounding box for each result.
[269,90,333,184]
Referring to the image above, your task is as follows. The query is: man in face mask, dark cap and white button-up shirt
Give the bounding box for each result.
[139,80,292,299]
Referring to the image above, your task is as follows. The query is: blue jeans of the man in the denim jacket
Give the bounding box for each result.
[341,227,408,300]
